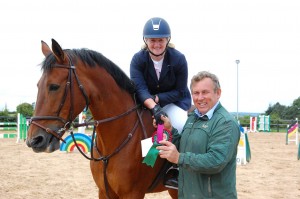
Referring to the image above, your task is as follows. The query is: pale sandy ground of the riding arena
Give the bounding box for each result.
[0,133,300,199]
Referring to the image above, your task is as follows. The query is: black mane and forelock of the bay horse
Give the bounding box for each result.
[41,48,135,93]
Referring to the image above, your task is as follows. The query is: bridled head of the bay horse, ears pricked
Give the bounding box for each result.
[26,39,88,152]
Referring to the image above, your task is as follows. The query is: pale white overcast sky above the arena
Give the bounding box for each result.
[0,0,300,112]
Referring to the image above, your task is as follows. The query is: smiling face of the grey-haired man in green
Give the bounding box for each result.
[191,78,221,115]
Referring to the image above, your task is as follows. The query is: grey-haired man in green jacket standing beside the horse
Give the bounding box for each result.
[157,71,240,199]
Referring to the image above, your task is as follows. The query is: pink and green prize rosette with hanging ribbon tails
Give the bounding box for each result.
[143,124,172,168]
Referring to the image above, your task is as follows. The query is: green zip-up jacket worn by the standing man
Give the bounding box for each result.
[173,104,240,199]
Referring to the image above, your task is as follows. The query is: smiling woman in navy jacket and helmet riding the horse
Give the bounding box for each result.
[130,17,191,186]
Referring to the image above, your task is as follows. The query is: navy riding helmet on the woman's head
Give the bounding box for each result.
[143,17,171,39]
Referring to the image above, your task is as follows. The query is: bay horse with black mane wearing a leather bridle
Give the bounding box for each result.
[26,39,177,199]
